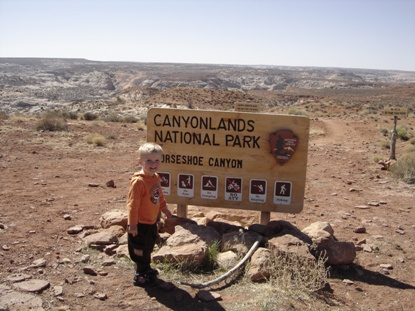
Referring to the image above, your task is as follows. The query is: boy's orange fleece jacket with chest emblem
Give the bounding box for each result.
[127,173,167,226]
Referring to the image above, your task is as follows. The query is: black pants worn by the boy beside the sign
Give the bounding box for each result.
[128,224,157,273]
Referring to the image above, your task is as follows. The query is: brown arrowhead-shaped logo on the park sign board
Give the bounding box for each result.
[270,130,299,165]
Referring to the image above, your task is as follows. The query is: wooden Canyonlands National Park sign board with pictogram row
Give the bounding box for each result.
[147,108,310,213]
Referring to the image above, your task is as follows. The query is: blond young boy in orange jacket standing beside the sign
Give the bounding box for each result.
[127,143,172,286]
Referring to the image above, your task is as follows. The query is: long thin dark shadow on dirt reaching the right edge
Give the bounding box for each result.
[330,265,415,289]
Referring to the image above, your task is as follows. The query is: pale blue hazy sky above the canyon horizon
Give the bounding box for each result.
[0,0,415,71]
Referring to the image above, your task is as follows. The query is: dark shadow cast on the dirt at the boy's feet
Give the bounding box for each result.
[145,280,225,311]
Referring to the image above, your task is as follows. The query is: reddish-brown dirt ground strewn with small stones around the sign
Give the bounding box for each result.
[0,109,415,311]
